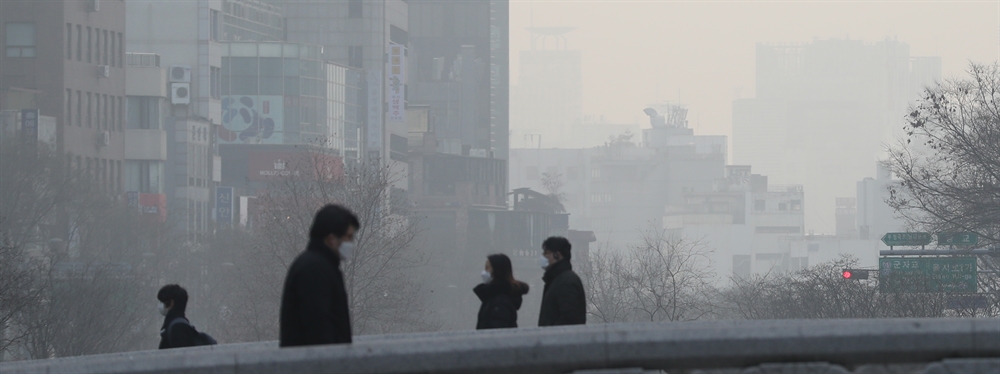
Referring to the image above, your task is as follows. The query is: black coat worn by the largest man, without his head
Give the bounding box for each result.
[279,240,351,347]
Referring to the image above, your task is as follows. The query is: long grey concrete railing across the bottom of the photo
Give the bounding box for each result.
[0,319,1000,374]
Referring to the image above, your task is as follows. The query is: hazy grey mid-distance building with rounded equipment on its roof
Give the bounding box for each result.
[510,105,727,248]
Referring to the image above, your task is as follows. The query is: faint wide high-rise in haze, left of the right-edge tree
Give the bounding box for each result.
[733,40,941,233]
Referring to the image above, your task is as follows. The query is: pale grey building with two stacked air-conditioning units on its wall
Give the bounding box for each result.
[126,0,225,242]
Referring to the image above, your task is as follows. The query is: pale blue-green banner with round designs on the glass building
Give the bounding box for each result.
[219,95,285,144]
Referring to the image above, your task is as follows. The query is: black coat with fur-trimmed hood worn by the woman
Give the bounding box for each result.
[472,281,528,330]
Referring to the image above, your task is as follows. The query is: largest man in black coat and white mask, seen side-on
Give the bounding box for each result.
[280,204,361,347]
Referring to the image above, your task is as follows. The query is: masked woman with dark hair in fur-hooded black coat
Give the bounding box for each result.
[472,254,528,330]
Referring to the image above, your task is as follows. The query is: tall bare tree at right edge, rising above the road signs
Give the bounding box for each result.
[887,63,1000,243]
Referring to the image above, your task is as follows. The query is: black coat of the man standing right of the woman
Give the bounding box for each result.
[538,260,587,326]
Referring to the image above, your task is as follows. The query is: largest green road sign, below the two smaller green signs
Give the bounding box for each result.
[878,257,978,293]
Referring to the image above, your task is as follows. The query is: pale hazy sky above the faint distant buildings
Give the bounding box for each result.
[510,0,1000,140]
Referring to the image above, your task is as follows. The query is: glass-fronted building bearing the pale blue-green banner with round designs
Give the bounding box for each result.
[218,42,363,154]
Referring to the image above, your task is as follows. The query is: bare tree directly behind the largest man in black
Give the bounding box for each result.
[228,154,437,341]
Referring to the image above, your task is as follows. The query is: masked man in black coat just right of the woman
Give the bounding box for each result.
[538,236,587,327]
